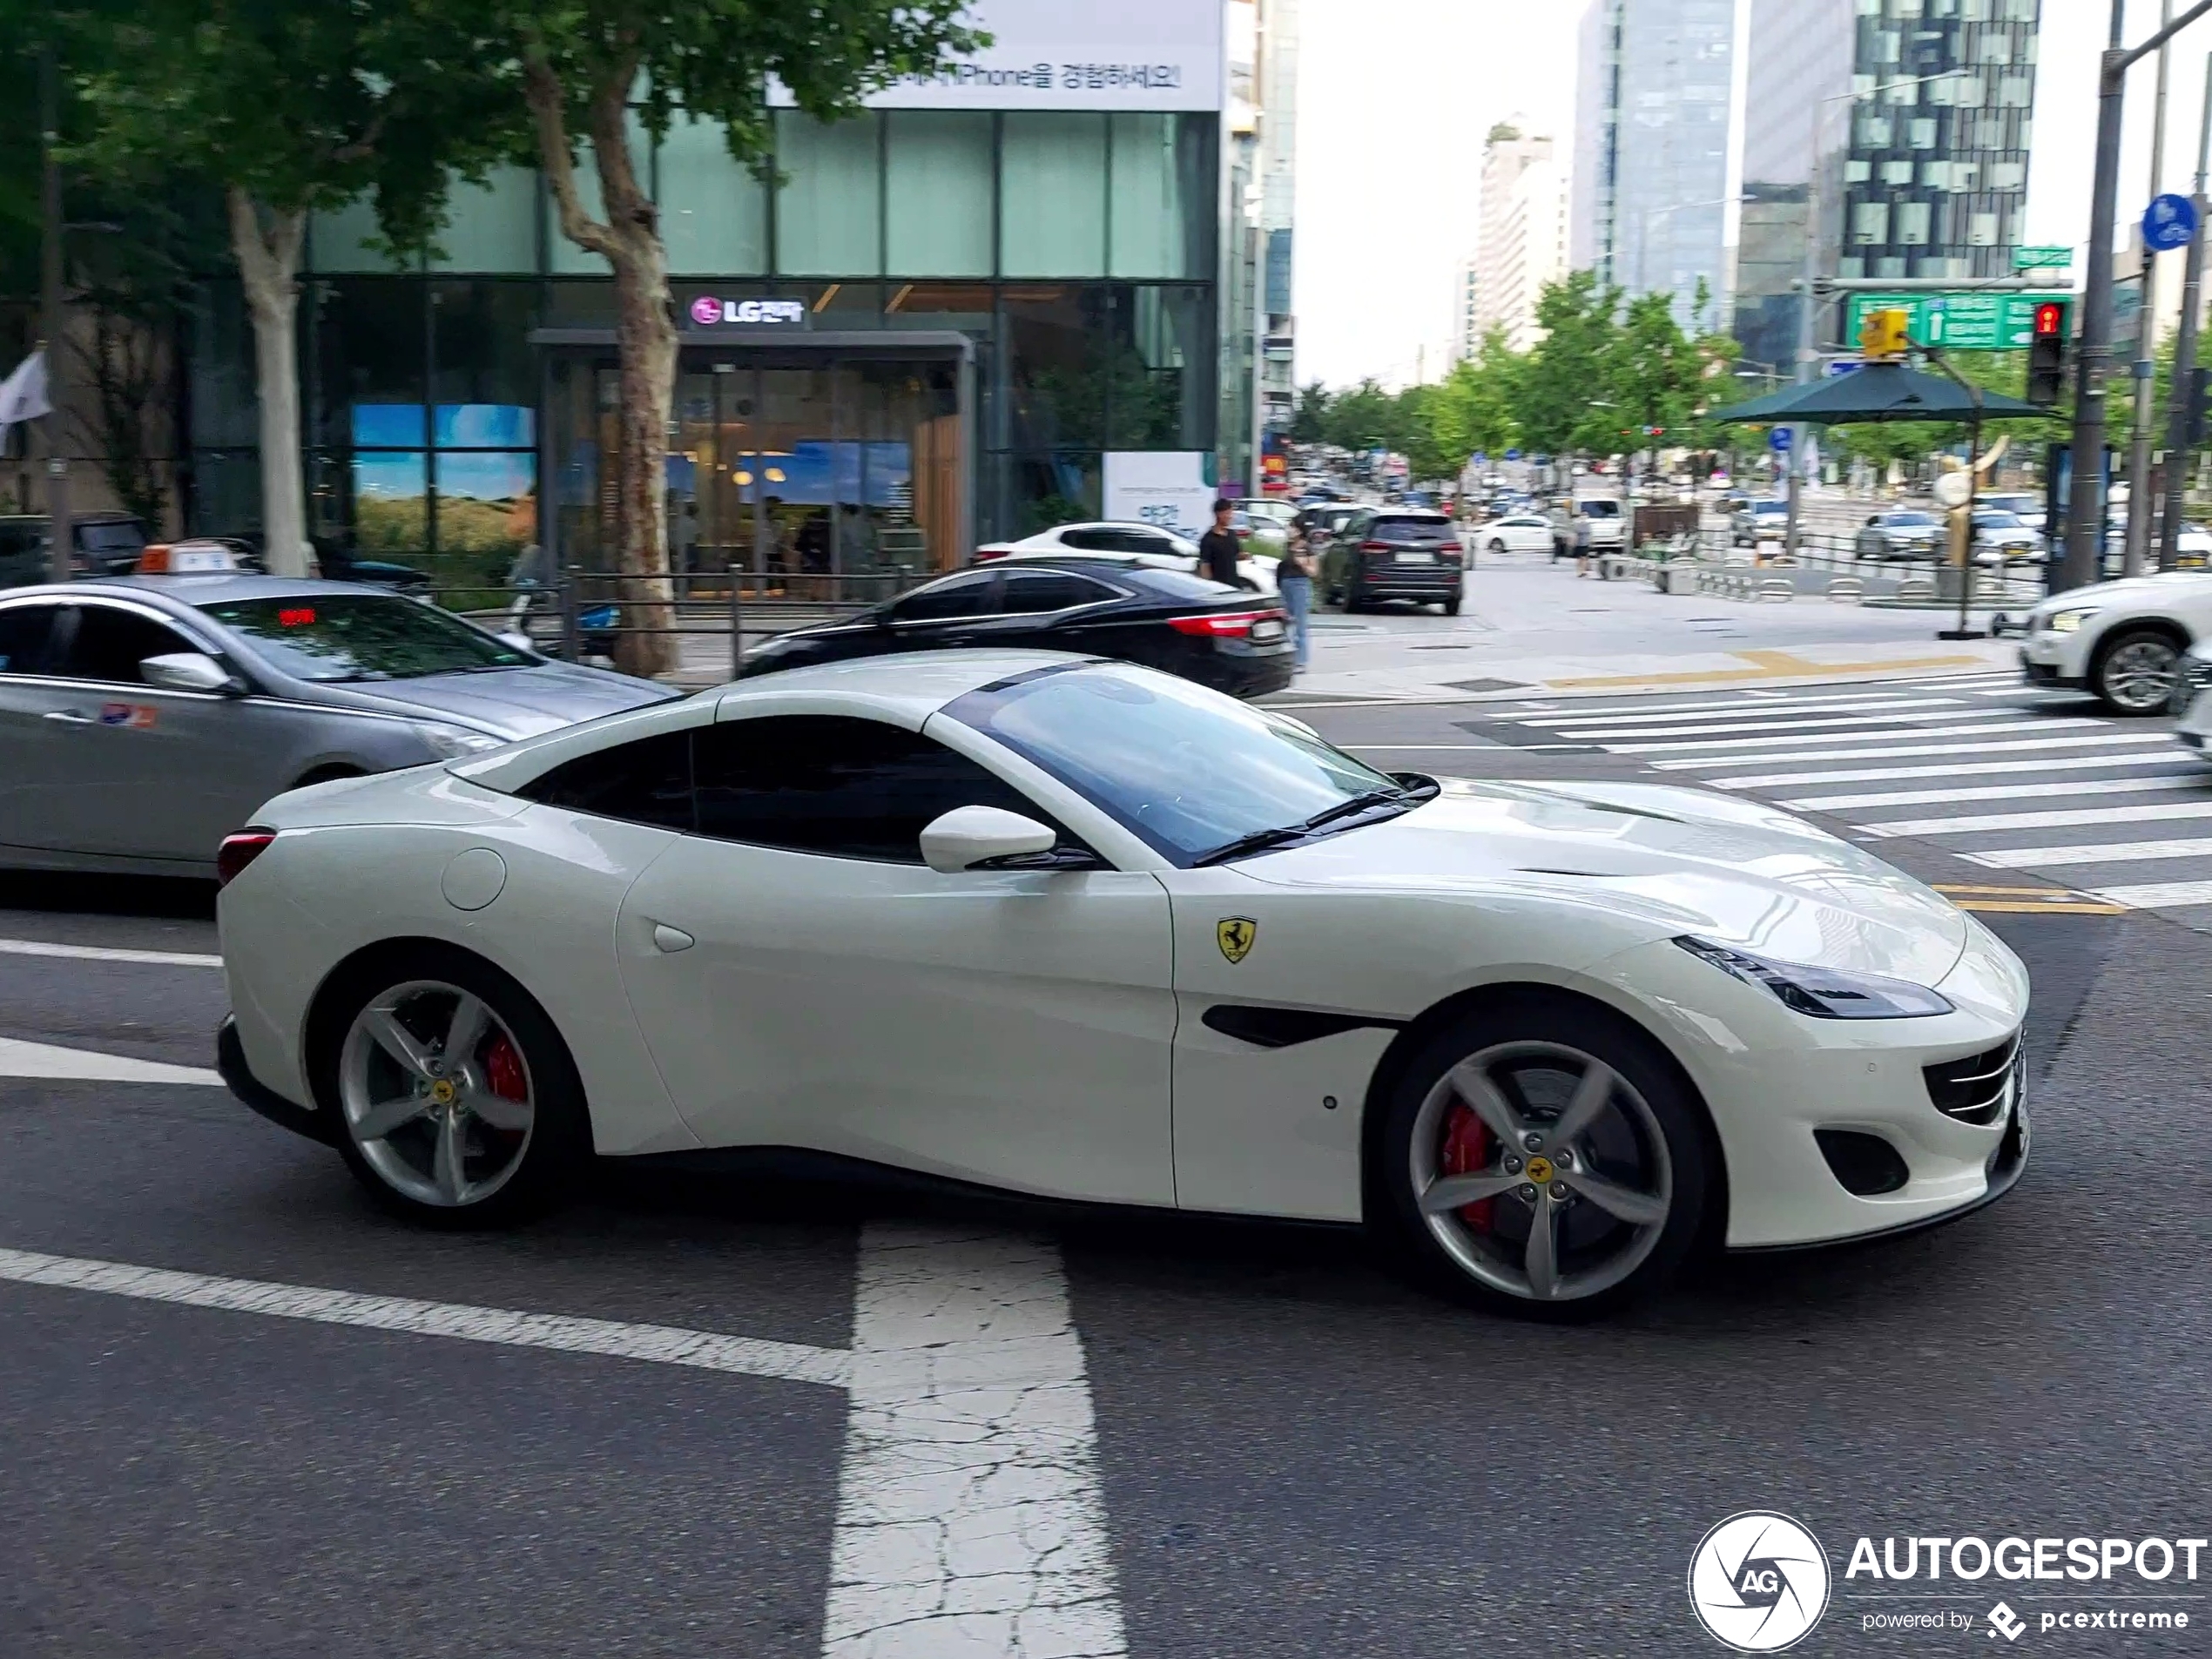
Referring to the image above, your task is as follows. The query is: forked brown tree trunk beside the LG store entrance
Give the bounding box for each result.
[524,51,677,675]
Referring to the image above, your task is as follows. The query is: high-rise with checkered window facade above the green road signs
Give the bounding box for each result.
[1734,0,2040,376]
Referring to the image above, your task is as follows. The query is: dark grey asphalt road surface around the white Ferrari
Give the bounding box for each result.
[0,681,2212,1659]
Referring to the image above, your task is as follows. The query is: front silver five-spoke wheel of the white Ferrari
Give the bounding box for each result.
[1412,1042,1675,1303]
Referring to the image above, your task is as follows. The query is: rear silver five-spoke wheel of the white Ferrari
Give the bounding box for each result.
[339,980,537,1208]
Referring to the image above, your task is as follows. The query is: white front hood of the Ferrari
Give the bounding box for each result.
[1238,779,1966,984]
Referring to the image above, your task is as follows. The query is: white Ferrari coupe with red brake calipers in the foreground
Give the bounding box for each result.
[219,652,2028,1314]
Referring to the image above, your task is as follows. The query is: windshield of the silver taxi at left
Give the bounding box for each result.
[199,593,537,685]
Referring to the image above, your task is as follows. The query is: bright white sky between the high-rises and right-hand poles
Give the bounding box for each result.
[1294,0,2212,385]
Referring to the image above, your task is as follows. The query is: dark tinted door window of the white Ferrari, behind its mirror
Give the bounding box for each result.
[695,714,1044,865]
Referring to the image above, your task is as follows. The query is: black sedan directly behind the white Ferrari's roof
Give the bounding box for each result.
[741,557,1291,697]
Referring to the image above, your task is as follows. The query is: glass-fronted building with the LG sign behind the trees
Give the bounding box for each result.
[188,102,1224,579]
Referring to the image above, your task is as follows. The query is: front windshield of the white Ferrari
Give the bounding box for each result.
[945,664,1405,867]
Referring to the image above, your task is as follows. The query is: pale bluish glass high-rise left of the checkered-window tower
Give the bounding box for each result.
[1570,0,1737,319]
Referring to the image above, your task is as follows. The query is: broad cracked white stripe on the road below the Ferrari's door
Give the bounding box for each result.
[823,1224,1128,1659]
